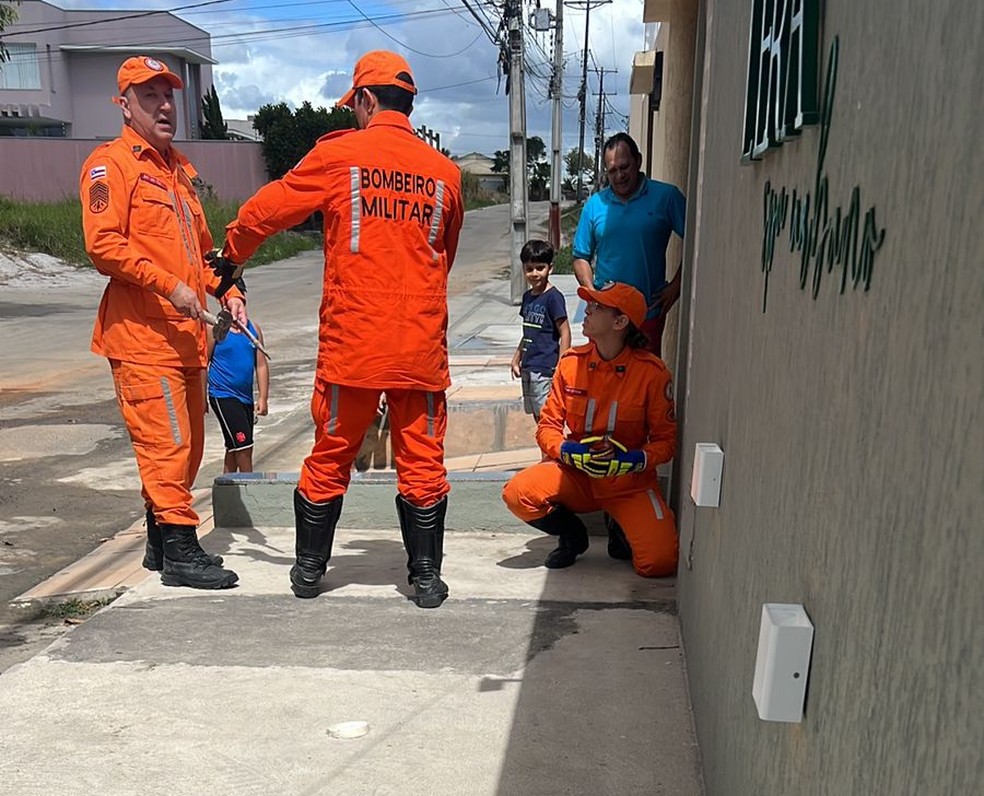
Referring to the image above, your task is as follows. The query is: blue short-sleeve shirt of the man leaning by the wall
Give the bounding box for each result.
[573,177,687,317]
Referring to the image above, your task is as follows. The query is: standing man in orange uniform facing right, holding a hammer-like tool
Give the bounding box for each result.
[80,56,246,589]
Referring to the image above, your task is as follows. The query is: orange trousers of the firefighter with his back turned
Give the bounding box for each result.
[298,380,451,508]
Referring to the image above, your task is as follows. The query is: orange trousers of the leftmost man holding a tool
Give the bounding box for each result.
[109,359,205,525]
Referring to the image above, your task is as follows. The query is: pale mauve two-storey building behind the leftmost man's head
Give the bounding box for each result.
[0,0,216,139]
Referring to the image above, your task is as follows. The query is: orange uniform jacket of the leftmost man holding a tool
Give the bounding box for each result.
[80,126,242,367]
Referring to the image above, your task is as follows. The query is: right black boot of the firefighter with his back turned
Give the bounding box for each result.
[396,495,448,608]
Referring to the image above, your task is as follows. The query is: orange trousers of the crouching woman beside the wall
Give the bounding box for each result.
[502,461,679,578]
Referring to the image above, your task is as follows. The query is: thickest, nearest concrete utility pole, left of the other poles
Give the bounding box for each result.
[504,0,529,305]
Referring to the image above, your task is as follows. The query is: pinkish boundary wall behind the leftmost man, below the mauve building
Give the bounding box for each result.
[0,138,267,202]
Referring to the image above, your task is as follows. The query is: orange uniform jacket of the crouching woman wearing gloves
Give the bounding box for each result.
[536,343,676,494]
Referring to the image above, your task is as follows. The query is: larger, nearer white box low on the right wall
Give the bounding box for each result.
[752,603,813,722]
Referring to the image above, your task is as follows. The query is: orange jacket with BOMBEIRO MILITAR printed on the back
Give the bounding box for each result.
[224,111,464,391]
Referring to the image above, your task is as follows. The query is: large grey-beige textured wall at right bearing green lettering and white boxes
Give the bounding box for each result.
[678,0,984,796]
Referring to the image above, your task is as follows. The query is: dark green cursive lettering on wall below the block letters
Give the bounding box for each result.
[762,37,885,312]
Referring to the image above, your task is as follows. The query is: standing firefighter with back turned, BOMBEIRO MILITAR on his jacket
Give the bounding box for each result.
[217,50,464,608]
